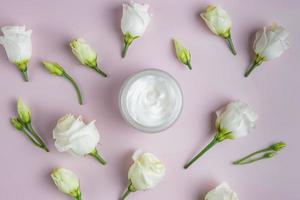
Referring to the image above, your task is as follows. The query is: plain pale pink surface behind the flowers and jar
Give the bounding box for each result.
[0,0,300,200]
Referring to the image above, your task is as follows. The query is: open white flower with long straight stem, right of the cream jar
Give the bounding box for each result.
[184,101,258,169]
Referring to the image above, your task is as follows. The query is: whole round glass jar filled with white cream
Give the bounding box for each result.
[120,69,183,132]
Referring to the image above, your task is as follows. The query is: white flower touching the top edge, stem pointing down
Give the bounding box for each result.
[121,1,151,57]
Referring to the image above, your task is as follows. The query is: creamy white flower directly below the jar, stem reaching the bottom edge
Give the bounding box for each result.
[121,150,166,200]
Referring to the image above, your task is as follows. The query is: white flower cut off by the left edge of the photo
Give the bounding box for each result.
[0,26,32,81]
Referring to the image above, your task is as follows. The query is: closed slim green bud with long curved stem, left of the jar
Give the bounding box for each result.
[42,61,83,105]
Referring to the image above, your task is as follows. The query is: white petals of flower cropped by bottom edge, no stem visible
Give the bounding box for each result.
[204,182,238,200]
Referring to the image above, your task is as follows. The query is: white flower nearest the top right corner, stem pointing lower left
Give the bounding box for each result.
[245,23,289,77]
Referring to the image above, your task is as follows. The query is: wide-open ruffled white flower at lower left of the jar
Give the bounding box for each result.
[53,114,106,165]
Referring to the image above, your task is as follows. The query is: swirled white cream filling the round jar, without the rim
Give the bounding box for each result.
[126,74,182,127]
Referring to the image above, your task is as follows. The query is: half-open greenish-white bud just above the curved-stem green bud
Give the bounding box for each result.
[70,38,107,77]
